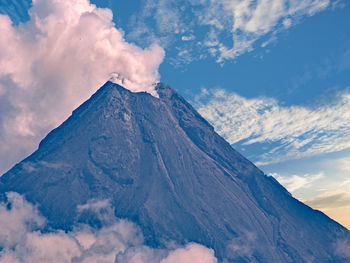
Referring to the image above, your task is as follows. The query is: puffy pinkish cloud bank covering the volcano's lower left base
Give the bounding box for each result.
[0,192,217,263]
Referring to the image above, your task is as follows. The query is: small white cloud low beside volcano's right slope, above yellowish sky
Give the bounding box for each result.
[270,173,324,193]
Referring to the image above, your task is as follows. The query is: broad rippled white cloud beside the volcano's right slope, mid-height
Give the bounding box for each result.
[195,90,350,165]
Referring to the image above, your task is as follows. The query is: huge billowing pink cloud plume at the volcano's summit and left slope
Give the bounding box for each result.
[0,0,164,173]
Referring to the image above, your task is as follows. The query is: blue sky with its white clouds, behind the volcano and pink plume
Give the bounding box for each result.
[0,0,350,227]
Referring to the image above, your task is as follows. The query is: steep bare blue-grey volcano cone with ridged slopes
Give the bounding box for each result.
[0,82,350,262]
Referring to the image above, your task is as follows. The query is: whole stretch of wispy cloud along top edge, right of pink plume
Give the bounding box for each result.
[130,0,331,62]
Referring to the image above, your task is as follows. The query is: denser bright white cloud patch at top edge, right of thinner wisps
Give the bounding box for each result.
[210,0,330,60]
